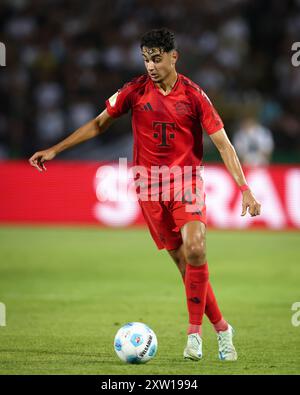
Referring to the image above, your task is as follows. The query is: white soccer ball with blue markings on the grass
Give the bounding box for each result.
[114,322,157,363]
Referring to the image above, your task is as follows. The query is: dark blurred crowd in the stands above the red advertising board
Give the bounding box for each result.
[0,0,300,162]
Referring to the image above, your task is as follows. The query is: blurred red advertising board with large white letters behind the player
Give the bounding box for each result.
[0,160,300,230]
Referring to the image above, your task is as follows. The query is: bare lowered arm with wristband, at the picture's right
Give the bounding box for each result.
[209,128,261,217]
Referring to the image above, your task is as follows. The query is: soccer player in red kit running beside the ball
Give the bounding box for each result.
[29,29,260,361]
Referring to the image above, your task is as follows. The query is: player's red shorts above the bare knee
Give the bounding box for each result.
[139,183,206,250]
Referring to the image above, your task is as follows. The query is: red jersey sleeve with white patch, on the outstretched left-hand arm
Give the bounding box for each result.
[105,84,133,118]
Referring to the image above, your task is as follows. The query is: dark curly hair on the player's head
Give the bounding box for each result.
[141,28,177,52]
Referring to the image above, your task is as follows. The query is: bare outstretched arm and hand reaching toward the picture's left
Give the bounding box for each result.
[29,109,114,171]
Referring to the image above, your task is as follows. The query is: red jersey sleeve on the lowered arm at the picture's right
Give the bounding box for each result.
[199,90,224,134]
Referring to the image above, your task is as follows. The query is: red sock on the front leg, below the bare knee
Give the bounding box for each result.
[185,263,209,330]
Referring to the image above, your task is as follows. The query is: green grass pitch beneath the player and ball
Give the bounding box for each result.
[0,227,300,375]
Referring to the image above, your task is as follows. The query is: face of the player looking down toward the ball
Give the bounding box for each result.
[142,47,177,83]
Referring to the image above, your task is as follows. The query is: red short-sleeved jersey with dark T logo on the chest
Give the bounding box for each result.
[106,74,223,169]
